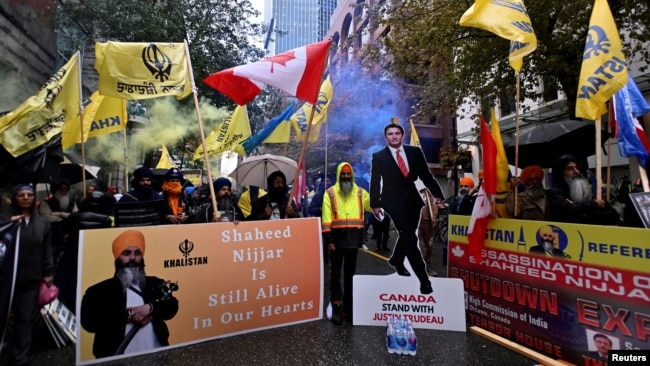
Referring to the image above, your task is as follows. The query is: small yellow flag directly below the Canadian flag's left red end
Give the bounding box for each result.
[192,105,252,160]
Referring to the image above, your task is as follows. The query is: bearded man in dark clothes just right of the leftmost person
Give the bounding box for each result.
[38,179,78,272]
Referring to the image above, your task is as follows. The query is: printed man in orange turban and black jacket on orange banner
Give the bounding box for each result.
[80,230,178,358]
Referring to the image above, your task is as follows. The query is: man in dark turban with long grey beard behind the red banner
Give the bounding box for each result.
[547,155,619,225]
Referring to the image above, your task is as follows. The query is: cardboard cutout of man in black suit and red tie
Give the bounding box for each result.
[370,123,444,294]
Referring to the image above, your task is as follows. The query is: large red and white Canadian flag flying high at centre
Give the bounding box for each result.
[203,39,332,105]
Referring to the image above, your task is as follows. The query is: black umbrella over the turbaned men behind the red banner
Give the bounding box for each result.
[506,120,610,168]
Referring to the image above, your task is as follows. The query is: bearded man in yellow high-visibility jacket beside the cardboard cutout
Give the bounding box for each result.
[321,162,372,325]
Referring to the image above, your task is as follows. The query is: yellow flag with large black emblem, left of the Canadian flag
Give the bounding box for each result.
[95,42,192,100]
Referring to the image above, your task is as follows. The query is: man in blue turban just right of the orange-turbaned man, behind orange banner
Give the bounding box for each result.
[194,177,244,223]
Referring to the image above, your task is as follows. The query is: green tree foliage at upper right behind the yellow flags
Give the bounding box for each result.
[365,0,650,123]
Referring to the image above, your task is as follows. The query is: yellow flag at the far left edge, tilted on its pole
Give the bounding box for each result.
[0,52,81,156]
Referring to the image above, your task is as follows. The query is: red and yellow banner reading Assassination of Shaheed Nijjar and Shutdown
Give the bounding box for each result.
[448,216,650,365]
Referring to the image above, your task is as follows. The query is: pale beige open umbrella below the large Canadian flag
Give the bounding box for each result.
[229,154,298,188]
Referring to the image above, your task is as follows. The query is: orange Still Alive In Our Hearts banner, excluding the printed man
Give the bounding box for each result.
[77,218,323,363]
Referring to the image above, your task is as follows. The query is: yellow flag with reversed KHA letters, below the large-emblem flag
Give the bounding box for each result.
[61,91,128,150]
